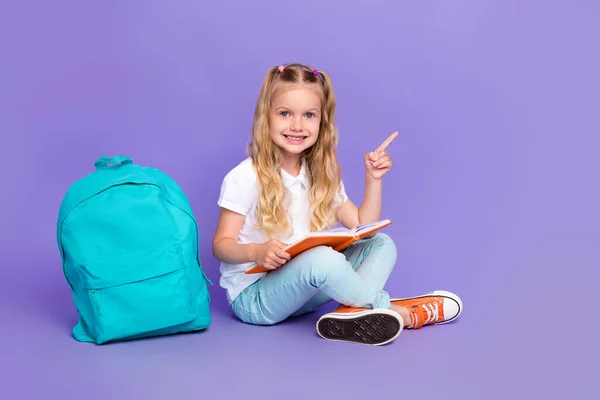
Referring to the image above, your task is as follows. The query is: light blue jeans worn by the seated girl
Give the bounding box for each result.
[231,233,397,325]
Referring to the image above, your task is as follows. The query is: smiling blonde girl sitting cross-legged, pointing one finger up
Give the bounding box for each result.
[213,64,462,345]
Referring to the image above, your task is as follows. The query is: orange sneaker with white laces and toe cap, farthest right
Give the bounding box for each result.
[391,290,463,329]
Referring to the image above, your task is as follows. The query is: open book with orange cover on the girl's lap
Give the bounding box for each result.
[244,219,392,274]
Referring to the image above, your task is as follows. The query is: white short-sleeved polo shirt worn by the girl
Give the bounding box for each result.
[217,157,348,304]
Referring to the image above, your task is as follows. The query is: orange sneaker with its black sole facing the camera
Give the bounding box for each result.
[317,306,404,346]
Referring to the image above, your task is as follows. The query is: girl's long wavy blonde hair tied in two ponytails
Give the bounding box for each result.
[247,63,342,238]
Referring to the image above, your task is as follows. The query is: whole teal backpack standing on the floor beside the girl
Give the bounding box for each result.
[57,156,212,344]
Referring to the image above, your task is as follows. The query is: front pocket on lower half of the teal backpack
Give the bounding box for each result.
[79,244,196,342]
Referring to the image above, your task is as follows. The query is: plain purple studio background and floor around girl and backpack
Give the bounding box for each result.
[0,0,600,400]
